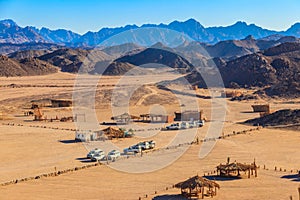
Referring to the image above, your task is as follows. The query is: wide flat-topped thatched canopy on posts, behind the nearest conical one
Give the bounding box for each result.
[216,161,257,178]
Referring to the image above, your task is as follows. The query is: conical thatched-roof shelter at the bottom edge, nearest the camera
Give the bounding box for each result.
[175,175,220,199]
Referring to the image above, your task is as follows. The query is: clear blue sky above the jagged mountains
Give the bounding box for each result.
[0,0,300,34]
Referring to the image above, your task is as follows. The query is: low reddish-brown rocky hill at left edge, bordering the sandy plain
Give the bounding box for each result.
[0,55,58,77]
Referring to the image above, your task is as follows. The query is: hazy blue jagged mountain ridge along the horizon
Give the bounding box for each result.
[0,19,300,47]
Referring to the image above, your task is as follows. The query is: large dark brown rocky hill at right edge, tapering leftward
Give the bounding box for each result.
[170,42,300,97]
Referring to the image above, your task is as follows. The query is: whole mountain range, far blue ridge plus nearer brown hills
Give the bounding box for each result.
[0,19,300,97]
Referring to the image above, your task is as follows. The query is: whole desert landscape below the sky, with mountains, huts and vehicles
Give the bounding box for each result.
[0,19,300,200]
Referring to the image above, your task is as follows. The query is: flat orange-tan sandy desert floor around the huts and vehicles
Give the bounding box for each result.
[0,72,300,200]
